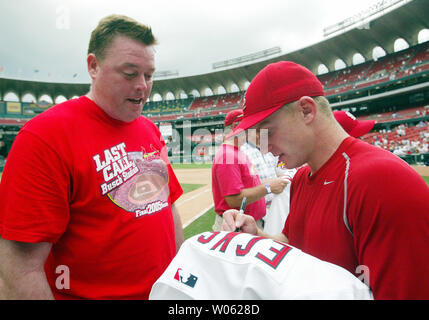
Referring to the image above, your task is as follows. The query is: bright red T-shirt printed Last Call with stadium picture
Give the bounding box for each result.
[0,96,182,299]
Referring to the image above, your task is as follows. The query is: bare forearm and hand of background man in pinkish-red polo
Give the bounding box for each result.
[225,178,289,208]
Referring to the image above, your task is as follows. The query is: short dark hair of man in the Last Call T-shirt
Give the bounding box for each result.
[88,14,157,61]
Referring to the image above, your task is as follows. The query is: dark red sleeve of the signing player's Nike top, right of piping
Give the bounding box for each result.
[347,160,429,299]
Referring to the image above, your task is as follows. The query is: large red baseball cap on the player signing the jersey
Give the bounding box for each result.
[229,61,325,136]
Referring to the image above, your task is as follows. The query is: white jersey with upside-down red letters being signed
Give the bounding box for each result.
[149,231,372,300]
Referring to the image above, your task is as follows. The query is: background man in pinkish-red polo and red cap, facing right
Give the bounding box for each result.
[212,109,286,231]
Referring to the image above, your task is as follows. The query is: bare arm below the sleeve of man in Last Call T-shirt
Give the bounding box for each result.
[0,238,54,300]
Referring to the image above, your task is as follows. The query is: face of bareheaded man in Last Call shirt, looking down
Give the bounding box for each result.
[88,36,155,122]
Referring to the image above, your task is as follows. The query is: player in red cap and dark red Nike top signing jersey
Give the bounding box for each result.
[222,61,429,299]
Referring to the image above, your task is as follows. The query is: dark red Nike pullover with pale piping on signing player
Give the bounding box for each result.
[283,138,429,299]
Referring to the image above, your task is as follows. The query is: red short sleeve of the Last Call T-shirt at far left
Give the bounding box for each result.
[0,130,71,243]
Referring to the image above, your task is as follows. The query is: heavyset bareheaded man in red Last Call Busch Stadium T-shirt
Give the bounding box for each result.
[0,15,183,299]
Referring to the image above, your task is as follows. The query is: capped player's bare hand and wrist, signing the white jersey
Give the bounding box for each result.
[222,209,289,243]
